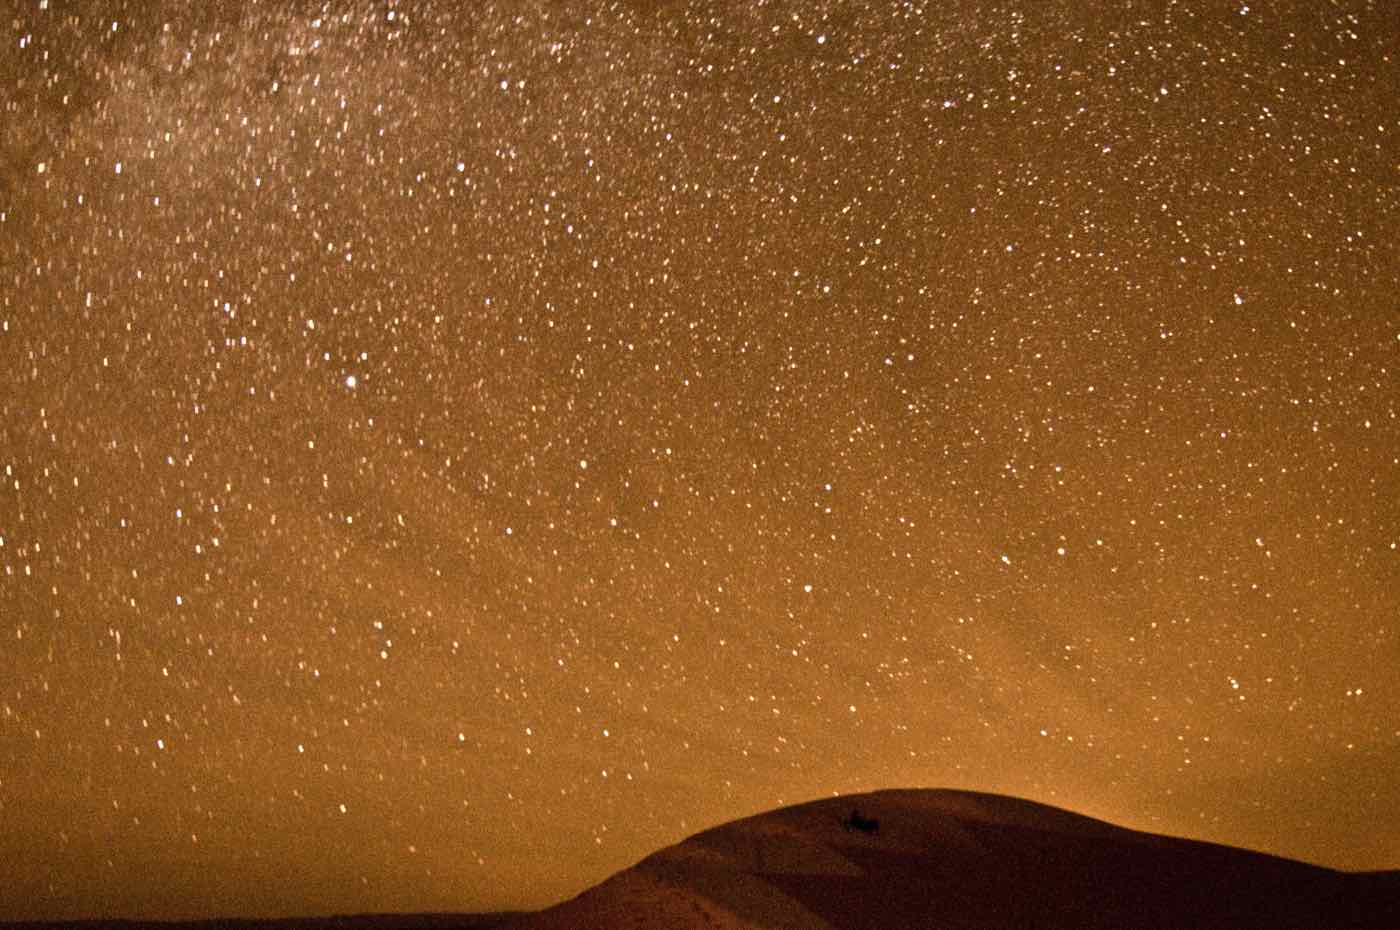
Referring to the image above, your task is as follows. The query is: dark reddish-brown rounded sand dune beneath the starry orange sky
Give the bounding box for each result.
[503,790,1400,930]
